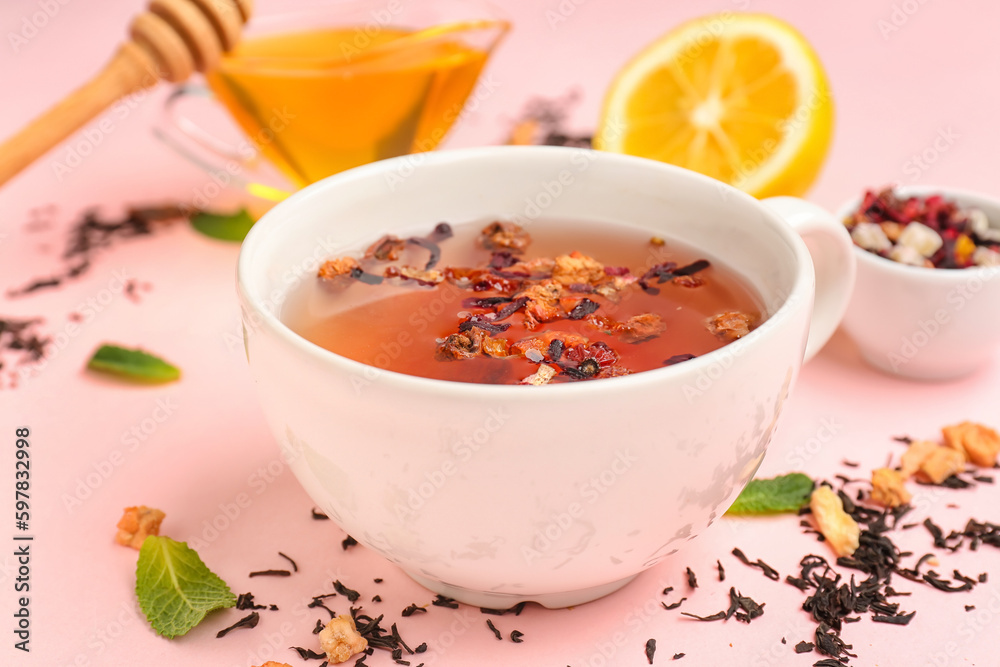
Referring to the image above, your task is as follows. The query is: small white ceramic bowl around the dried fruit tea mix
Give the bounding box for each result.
[837,186,1000,380]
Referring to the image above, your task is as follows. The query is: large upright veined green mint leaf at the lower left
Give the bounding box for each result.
[135,535,236,639]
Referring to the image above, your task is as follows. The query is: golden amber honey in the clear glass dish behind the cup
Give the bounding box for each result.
[206,20,508,187]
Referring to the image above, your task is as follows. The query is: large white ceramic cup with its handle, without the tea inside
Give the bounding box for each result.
[238,147,854,608]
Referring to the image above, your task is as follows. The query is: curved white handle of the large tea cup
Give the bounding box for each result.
[761,197,857,361]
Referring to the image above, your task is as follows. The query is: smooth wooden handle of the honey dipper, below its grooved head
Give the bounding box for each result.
[0,42,160,186]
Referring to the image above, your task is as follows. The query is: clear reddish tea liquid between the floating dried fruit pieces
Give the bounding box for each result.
[282,221,762,384]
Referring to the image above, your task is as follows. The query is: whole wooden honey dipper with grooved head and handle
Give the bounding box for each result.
[0,0,253,185]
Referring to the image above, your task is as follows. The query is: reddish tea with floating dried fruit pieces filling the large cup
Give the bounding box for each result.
[283,220,763,385]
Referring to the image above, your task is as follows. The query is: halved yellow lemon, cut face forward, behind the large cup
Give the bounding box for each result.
[594,12,833,197]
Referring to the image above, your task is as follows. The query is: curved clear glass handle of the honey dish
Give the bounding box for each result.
[153,84,291,201]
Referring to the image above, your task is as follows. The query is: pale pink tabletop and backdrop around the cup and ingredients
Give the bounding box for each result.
[0,0,1000,667]
